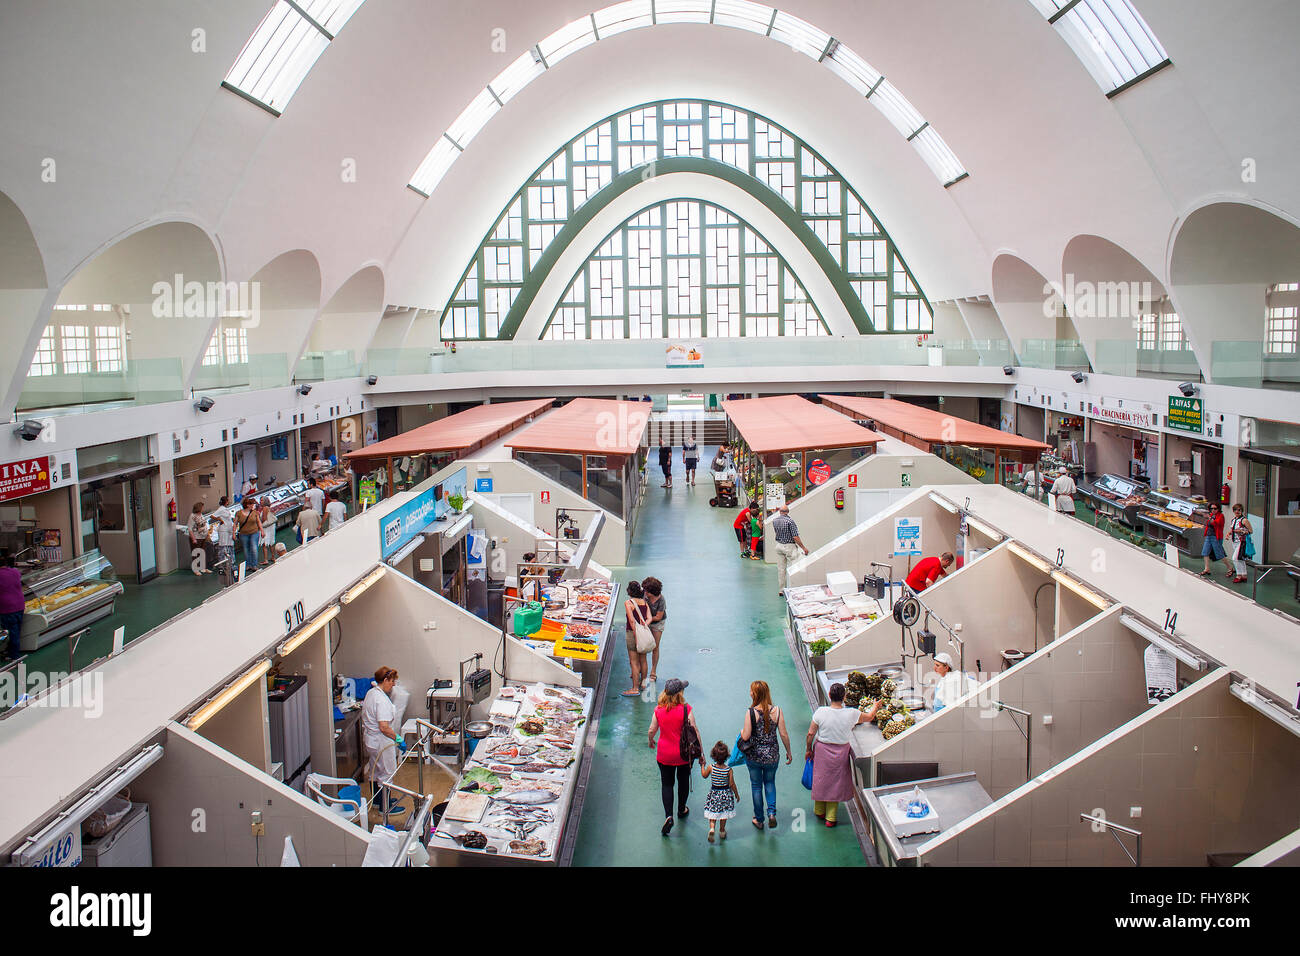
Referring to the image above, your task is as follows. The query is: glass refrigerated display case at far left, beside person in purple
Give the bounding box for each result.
[22,550,122,650]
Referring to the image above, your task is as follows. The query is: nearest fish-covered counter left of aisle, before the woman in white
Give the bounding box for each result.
[436,684,592,861]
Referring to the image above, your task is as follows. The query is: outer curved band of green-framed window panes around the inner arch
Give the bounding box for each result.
[442,100,933,341]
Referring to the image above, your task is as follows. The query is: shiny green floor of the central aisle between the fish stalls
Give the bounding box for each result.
[573,449,863,866]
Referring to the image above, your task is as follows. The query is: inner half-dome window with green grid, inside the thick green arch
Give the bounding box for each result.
[542,199,828,339]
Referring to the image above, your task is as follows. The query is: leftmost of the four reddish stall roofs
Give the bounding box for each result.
[343,398,551,497]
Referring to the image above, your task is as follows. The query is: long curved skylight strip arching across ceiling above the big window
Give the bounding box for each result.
[408,0,969,196]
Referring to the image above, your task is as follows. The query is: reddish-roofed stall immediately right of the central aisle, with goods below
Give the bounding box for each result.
[723,395,881,510]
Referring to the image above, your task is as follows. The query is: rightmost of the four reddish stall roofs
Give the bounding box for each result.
[820,395,1049,484]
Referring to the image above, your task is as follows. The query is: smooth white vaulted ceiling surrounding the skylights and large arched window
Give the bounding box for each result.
[0,0,1300,390]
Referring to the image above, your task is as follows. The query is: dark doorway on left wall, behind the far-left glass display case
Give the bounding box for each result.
[81,467,159,584]
